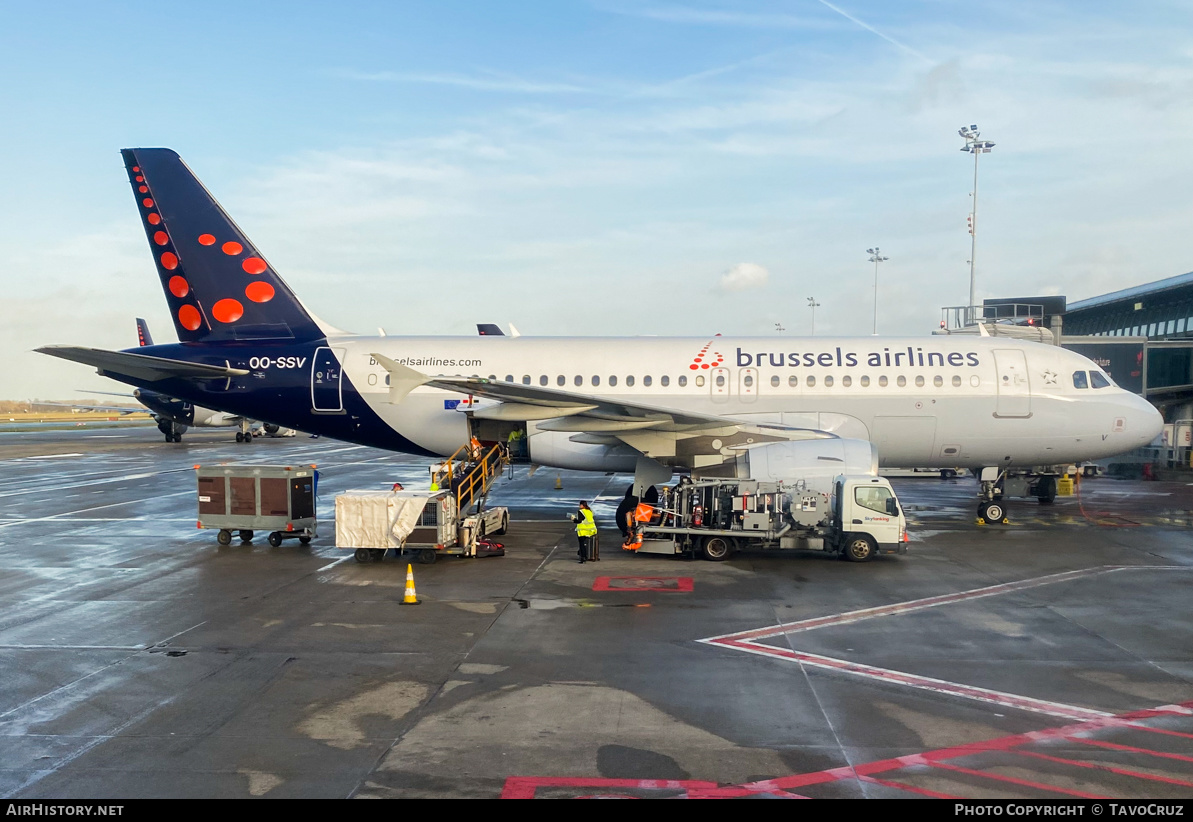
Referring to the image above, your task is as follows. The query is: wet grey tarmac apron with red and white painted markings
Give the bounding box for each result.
[0,428,1193,799]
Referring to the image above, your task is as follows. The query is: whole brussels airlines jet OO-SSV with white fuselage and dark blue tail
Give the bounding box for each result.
[38,148,1162,510]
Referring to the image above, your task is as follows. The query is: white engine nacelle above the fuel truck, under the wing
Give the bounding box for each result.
[735,437,878,493]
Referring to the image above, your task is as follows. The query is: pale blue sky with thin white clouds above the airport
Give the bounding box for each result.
[0,0,1193,400]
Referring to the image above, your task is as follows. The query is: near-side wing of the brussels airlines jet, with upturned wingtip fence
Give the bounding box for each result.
[372,354,835,445]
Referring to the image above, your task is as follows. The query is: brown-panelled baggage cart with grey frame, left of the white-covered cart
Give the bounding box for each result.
[194,464,319,548]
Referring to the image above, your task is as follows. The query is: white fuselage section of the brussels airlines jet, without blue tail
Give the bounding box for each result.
[328,335,1162,470]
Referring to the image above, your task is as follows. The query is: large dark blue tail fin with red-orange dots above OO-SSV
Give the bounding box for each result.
[120,148,323,342]
